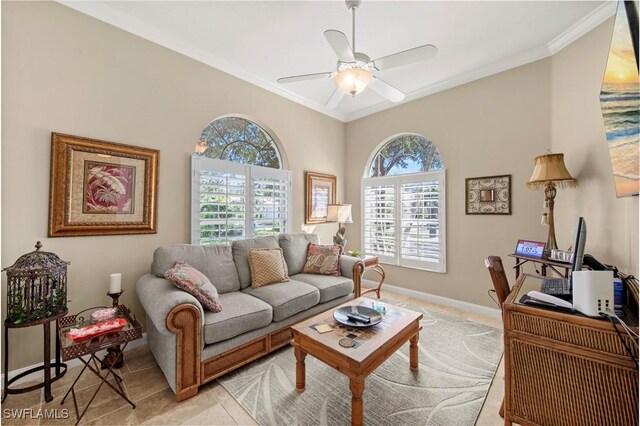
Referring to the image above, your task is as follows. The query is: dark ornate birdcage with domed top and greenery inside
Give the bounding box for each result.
[3,241,69,327]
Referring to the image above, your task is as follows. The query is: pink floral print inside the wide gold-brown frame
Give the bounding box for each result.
[82,161,136,214]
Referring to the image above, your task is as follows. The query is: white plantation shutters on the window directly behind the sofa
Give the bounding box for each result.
[191,155,291,244]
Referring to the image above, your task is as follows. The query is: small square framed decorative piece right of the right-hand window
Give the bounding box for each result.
[465,175,511,214]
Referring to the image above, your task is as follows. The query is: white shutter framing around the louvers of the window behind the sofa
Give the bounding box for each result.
[190,154,293,245]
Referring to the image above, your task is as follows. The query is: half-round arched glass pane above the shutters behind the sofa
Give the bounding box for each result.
[196,117,282,169]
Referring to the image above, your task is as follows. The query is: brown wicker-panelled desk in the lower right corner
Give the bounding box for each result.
[503,274,638,426]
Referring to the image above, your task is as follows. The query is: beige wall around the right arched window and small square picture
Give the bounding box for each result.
[345,59,551,307]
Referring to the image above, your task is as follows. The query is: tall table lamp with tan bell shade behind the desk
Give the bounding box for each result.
[527,154,578,257]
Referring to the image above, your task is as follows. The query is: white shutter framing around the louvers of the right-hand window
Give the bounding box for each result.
[360,170,447,274]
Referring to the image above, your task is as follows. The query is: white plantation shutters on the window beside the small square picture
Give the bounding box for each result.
[362,171,446,272]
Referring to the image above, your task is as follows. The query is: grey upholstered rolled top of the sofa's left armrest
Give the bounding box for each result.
[136,274,204,333]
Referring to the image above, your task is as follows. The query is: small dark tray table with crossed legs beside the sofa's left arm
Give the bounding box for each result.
[58,305,142,425]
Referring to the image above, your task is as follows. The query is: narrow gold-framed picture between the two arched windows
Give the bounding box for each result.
[304,172,337,224]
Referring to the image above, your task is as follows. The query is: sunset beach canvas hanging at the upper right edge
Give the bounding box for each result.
[600,2,640,197]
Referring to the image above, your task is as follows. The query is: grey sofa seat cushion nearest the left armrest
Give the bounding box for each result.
[204,291,273,345]
